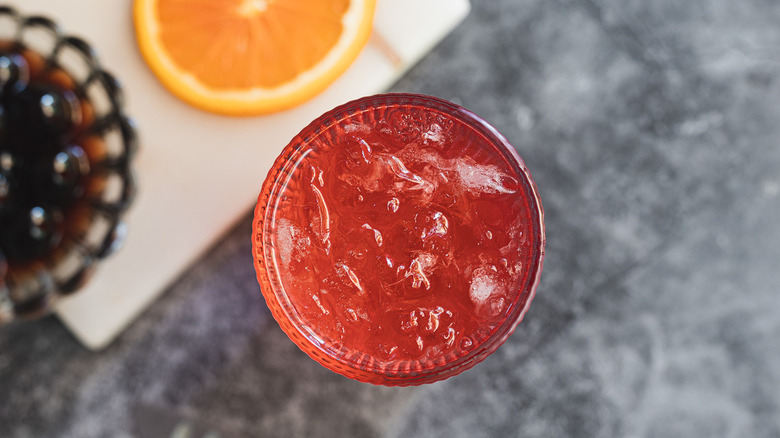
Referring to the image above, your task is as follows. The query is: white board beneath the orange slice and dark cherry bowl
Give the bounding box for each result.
[10,0,470,349]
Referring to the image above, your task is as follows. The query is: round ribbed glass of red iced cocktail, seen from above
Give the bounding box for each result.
[253,94,545,385]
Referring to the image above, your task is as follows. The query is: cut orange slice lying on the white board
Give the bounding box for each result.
[134,0,376,116]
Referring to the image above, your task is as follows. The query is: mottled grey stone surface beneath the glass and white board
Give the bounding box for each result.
[0,0,780,438]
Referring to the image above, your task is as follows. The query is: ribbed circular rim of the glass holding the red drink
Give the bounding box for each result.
[252,93,546,386]
